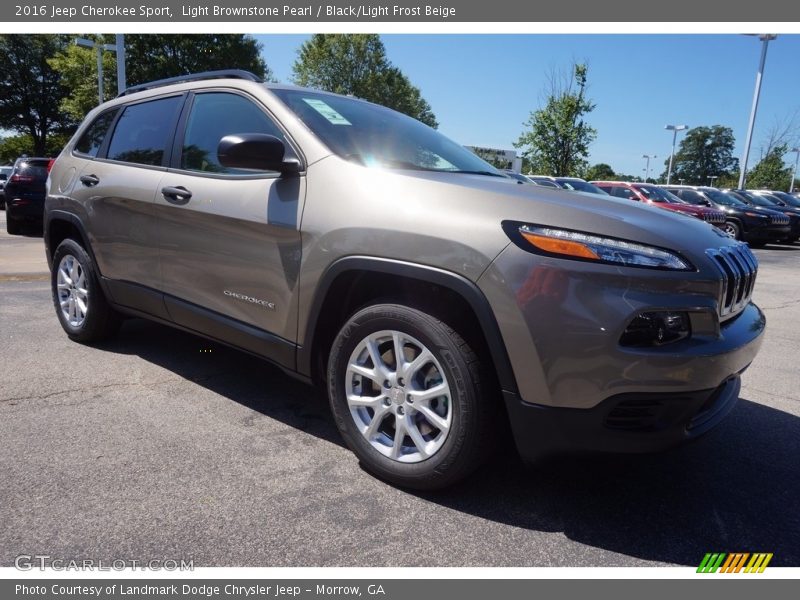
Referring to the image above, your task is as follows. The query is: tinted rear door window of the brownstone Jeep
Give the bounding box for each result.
[108,96,183,165]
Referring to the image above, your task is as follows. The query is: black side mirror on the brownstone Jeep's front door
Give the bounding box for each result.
[217,133,300,174]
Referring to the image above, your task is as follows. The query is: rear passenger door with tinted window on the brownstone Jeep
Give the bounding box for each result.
[71,94,184,294]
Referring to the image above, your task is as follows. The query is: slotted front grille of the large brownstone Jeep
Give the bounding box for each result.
[706,244,760,320]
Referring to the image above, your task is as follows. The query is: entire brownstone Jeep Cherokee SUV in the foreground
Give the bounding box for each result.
[45,71,765,489]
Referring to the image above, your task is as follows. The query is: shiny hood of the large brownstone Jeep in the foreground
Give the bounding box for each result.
[326,157,735,258]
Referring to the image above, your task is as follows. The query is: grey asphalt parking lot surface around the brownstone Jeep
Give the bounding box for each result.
[0,213,800,566]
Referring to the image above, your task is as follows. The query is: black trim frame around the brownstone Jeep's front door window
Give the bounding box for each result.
[167,87,308,181]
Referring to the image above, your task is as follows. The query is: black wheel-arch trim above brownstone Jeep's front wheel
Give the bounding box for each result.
[297,256,517,394]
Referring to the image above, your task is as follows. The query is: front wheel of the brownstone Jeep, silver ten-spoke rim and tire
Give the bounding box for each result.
[328,304,496,490]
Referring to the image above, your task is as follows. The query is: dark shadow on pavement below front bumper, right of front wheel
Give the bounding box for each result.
[426,398,800,566]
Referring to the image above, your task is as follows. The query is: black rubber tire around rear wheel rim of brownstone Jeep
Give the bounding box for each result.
[50,239,122,343]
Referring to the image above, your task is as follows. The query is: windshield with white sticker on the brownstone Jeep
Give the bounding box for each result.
[272,89,505,177]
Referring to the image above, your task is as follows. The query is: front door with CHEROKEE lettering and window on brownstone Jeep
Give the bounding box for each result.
[155,89,305,352]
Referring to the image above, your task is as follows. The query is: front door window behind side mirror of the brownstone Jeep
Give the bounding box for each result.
[181,92,291,174]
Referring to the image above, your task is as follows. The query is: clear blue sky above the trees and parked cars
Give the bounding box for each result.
[256,34,800,175]
